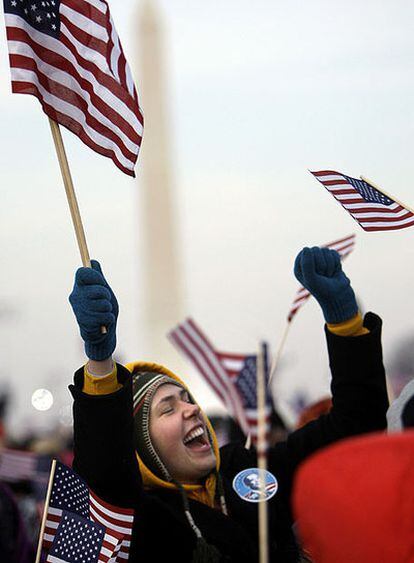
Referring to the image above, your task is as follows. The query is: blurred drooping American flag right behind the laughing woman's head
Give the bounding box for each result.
[168,318,273,444]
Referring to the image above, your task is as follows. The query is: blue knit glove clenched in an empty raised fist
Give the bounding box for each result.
[295,246,358,324]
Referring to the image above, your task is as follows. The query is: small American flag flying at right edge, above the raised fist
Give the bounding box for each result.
[311,170,414,231]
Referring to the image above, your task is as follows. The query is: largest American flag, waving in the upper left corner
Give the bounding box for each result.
[3,0,143,176]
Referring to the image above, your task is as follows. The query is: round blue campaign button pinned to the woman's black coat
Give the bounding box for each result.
[233,467,278,502]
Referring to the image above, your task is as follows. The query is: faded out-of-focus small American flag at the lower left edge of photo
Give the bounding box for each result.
[0,448,51,484]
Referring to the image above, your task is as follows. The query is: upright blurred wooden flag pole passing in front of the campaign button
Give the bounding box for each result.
[256,346,269,563]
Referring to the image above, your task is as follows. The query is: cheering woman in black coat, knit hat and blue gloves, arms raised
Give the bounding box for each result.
[70,247,388,563]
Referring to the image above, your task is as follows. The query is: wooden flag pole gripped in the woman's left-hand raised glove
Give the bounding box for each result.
[48,117,107,334]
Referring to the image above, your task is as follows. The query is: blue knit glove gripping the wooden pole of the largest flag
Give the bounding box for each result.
[69,260,119,361]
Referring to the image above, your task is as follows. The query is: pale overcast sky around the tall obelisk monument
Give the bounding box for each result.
[0,0,414,429]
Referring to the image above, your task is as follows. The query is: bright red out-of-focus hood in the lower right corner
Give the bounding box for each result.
[293,429,414,563]
